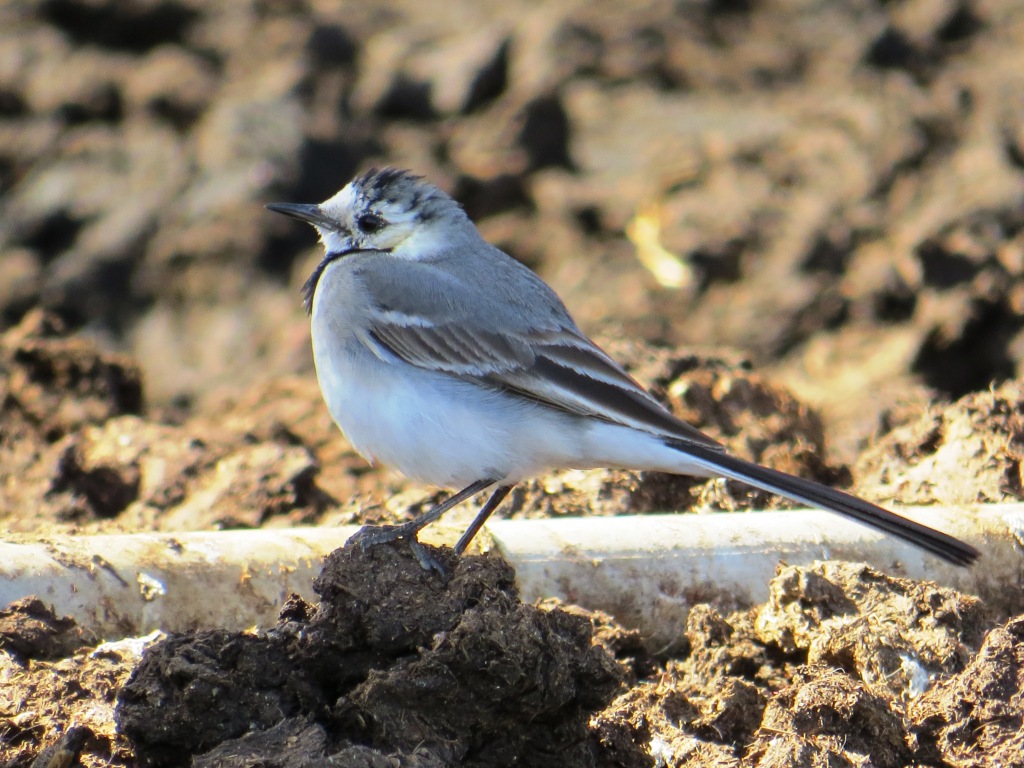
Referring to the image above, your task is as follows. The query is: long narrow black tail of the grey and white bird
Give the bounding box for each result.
[666,439,980,565]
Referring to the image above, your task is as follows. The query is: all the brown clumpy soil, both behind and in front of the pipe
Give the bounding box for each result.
[0,0,1024,768]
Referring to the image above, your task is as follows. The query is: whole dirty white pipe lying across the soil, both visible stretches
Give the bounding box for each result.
[0,504,1024,645]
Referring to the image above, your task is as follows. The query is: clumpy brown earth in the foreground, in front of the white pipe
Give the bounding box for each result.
[0,546,1024,768]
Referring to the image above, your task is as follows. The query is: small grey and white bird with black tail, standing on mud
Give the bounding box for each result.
[267,168,978,566]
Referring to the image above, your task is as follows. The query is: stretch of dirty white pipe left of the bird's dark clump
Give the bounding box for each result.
[0,526,357,640]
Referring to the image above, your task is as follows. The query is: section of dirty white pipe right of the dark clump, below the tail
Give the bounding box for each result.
[488,504,1024,647]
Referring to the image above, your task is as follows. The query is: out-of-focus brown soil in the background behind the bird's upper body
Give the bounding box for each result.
[0,0,1024,475]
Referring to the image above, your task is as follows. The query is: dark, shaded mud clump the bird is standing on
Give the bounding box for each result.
[117,546,626,766]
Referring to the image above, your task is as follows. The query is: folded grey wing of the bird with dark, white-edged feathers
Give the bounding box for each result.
[359,252,722,450]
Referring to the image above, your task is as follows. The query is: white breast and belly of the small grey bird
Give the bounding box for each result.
[311,263,584,487]
